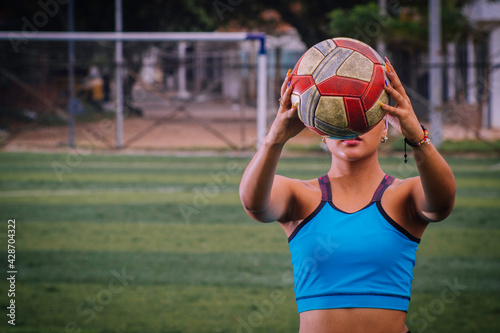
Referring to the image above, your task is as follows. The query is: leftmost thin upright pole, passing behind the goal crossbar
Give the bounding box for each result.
[68,0,76,148]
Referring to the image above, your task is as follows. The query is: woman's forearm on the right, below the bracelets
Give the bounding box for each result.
[413,143,456,220]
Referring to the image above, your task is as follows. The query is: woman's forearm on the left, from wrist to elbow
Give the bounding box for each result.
[240,137,283,212]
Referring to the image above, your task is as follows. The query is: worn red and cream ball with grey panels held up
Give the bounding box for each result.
[291,38,389,139]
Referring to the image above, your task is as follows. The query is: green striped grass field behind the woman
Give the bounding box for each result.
[0,153,500,333]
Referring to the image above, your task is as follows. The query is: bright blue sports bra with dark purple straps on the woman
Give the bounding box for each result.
[288,175,420,312]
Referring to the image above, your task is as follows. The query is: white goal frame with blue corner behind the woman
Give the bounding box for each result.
[0,31,267,149]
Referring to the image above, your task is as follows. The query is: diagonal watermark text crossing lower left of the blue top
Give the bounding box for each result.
[236,235,340,333]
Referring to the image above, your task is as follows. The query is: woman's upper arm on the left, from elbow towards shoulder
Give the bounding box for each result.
[244,175,294,222]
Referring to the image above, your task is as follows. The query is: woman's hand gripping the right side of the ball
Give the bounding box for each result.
[381,58,424,143]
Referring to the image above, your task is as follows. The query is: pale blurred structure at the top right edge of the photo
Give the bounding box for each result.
[464,0,500,128]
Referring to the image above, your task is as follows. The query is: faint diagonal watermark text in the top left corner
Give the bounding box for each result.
[8,0,69,53]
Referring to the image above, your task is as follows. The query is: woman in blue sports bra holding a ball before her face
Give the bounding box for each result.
[240,61,456,333]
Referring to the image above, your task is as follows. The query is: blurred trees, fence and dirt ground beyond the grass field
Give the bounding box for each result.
[0,0,500,150]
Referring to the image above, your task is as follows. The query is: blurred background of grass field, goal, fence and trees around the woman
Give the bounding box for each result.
[0,0,500,332]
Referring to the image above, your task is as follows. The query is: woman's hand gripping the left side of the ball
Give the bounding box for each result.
[266,73,305,144]
